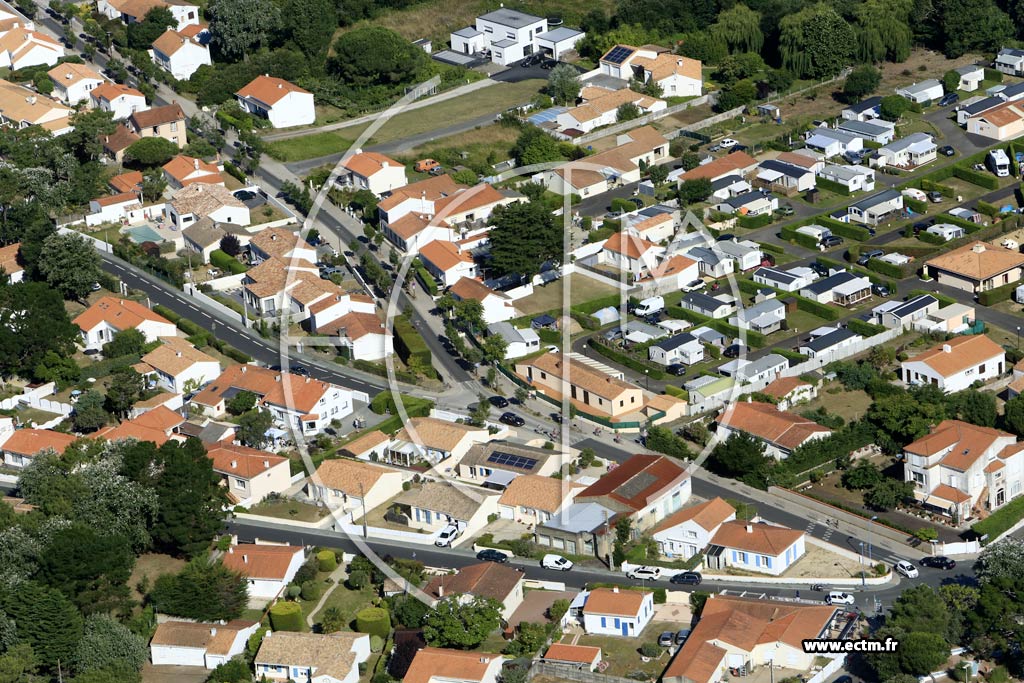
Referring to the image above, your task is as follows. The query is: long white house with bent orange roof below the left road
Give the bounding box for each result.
[190,366,353,435]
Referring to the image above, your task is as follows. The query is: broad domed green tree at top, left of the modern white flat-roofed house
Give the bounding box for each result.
[327,27,427,87]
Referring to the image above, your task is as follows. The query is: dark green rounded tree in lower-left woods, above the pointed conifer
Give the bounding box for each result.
[38,523,135,613]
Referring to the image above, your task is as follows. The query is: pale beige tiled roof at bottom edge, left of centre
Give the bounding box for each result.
[255,631,369,681]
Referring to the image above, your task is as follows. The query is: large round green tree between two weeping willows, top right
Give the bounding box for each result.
[779,2,854,79]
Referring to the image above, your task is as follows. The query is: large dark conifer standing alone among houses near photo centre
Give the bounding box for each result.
[490,201,563,279]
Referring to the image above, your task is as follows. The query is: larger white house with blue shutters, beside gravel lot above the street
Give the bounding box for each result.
[705,520,807,577]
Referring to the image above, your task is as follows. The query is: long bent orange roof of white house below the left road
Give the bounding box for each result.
[193,366,334,413]
